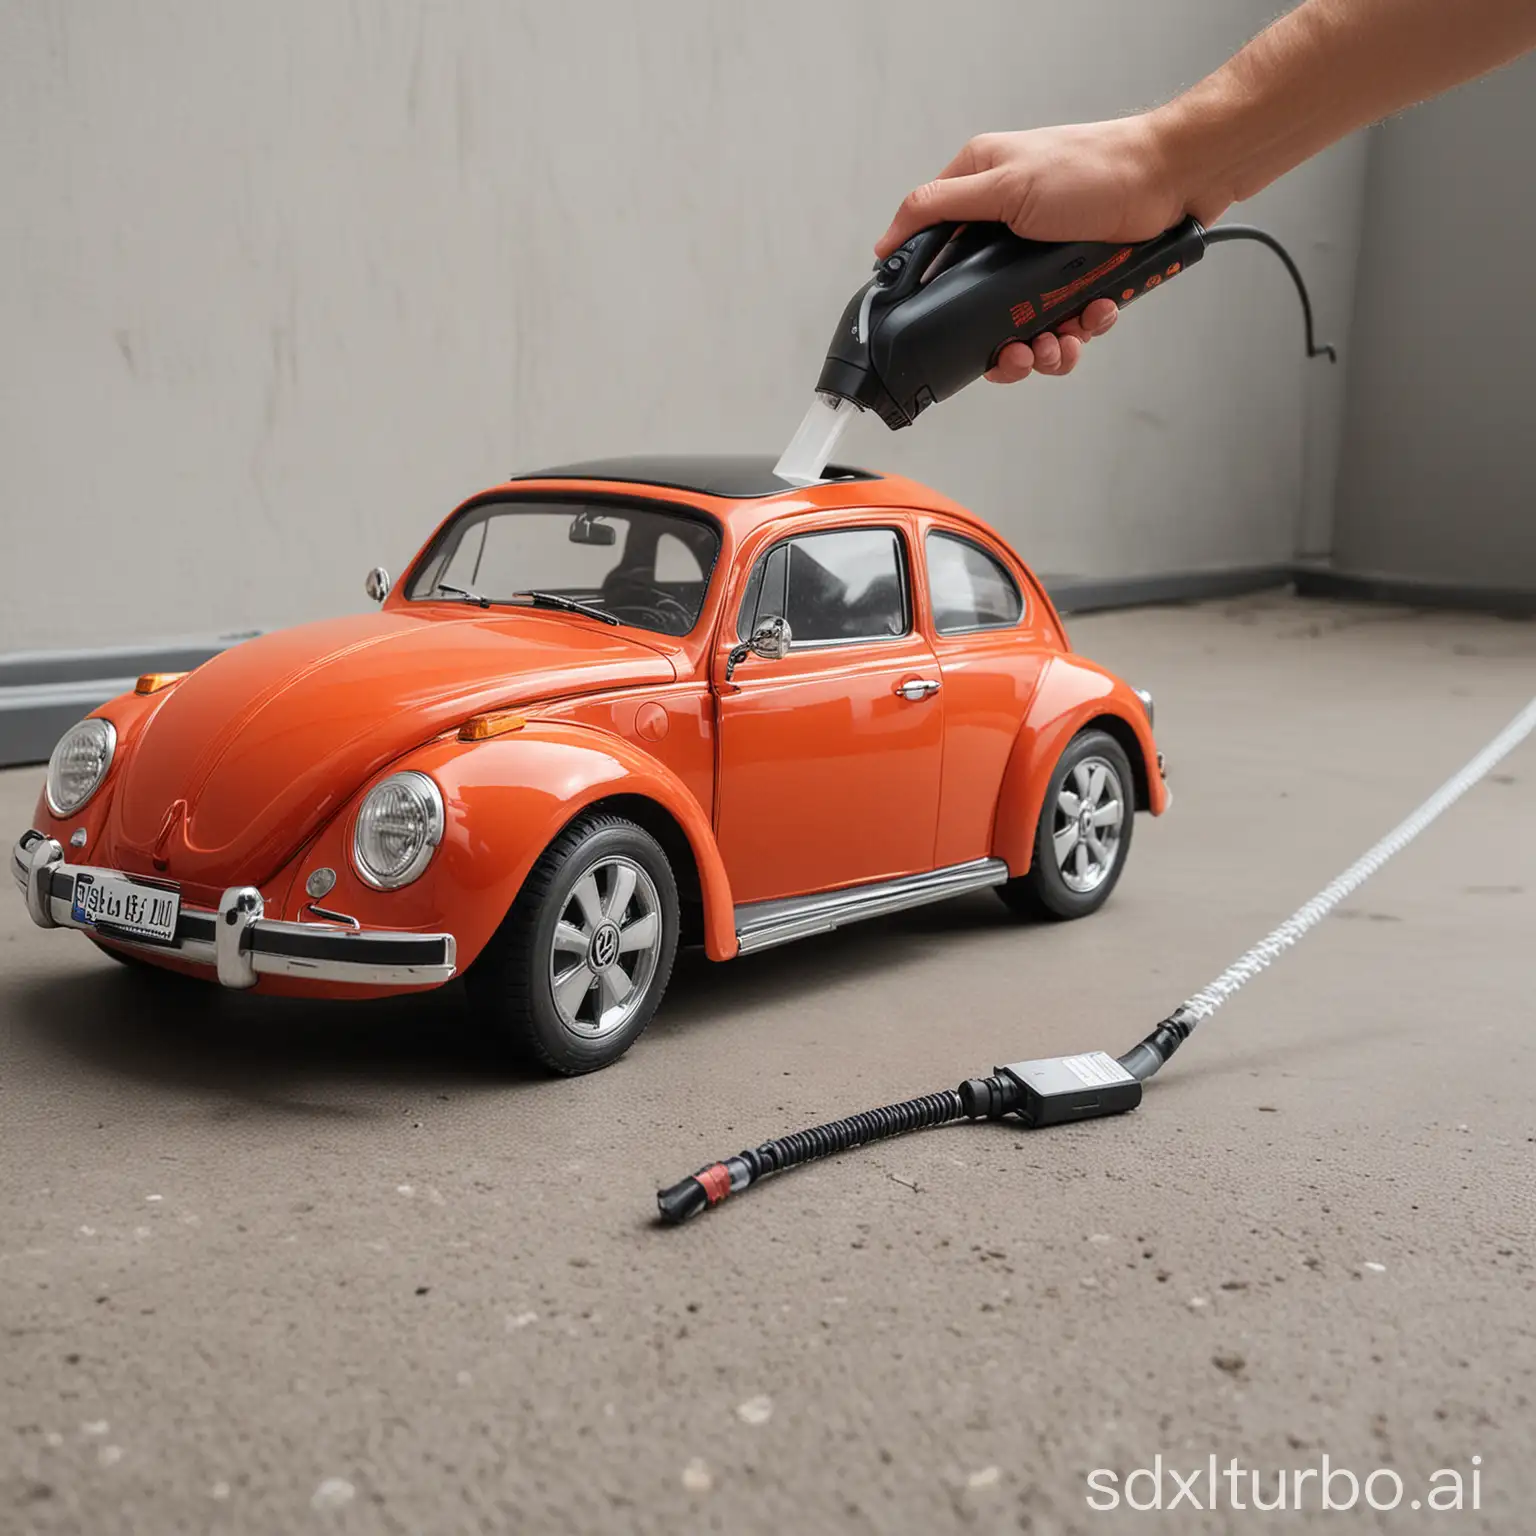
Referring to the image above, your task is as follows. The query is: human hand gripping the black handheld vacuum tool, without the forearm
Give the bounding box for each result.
[874,115,1224,384]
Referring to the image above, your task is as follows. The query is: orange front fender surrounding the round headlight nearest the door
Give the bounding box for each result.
[286,720,736,969]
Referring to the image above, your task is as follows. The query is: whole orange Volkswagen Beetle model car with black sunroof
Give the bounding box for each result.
[12,458,1167,1072]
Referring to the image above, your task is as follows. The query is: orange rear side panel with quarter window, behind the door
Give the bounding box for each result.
[923,522,1048,868]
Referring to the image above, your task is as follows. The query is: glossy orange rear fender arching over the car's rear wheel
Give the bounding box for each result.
[992,654,1167,876]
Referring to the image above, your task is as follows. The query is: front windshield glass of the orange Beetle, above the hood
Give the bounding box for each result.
[406,498,720,634]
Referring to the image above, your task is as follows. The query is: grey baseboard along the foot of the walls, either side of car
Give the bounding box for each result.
[0,565,1536,768]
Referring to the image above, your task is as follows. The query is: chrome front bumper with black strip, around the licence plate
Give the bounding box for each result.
[11,831,456,988]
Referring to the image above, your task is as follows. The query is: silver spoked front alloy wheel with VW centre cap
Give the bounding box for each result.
[550,854,662,1040]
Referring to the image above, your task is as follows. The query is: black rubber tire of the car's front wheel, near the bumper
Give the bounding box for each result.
[464,813,677,1077]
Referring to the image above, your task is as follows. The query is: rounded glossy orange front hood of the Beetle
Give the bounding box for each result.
[109,608,676,885]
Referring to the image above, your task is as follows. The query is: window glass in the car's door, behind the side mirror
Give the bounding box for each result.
[736,528,911,645]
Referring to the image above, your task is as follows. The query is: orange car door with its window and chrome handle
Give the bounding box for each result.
[716,515,945,903]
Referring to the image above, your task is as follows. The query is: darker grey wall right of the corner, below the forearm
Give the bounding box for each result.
[1335,55,1536,593]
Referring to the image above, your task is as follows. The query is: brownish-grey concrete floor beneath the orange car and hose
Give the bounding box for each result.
[0,598,1536,1536]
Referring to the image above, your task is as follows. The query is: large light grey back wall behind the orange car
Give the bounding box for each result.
[0,0,1364,651]
